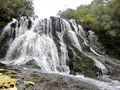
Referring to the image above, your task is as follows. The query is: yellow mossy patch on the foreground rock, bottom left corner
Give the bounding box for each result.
[0,68,35,90]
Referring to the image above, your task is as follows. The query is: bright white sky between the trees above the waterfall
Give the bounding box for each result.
[33,0,92,18]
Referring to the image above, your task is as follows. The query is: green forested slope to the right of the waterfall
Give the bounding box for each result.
[58,0,120,59]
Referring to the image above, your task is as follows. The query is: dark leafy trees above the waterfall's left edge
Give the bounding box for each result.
[0,0,34,29]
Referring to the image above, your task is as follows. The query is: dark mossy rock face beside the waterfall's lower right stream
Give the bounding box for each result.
[68,47,100,77]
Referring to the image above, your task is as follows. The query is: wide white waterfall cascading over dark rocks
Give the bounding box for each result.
[0,17,107,74]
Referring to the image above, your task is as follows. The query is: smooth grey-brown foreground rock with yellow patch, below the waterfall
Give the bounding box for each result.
[0,64,119,90]
